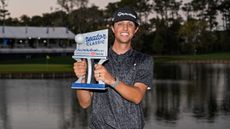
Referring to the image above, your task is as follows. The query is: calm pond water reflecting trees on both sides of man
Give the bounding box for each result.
[0,64,230,129]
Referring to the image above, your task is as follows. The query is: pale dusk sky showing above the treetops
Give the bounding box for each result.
[6,0,119,18]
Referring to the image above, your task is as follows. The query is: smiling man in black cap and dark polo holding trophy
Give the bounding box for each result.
[74,7,153,129]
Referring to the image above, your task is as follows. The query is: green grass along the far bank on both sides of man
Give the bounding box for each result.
[0,53,230,73]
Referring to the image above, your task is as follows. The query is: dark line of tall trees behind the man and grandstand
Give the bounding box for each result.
[0,0,230,55]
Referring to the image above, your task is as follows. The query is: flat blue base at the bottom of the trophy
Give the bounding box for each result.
[71,82,106,90]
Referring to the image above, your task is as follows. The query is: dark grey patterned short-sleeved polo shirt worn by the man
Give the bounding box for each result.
[89,48,153,129]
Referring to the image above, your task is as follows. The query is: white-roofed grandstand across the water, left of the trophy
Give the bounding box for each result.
[0,26,75,54]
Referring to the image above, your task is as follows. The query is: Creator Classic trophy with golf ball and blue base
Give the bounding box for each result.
[71,29,108,90]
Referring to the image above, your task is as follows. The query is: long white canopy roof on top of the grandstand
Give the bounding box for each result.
[0,26,75,39]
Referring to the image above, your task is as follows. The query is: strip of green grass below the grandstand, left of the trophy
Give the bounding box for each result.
[0,56,74,73]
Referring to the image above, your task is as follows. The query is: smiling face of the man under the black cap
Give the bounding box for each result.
[112,21,138,43]
